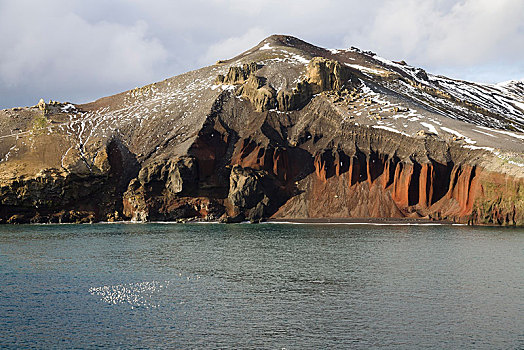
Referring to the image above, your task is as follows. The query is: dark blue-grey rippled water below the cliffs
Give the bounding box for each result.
[0,224,524,349]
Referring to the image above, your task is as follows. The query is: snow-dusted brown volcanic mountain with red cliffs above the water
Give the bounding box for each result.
[0,35,524,225]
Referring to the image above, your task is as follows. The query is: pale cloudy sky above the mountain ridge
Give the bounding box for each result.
[0,0,524,108]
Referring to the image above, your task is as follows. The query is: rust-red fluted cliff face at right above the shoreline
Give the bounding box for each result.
[274,147,524,224]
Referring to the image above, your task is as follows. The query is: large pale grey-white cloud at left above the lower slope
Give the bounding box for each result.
[0,2,167,104]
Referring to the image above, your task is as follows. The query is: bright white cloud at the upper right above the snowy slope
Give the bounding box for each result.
[344,0,524,68]
